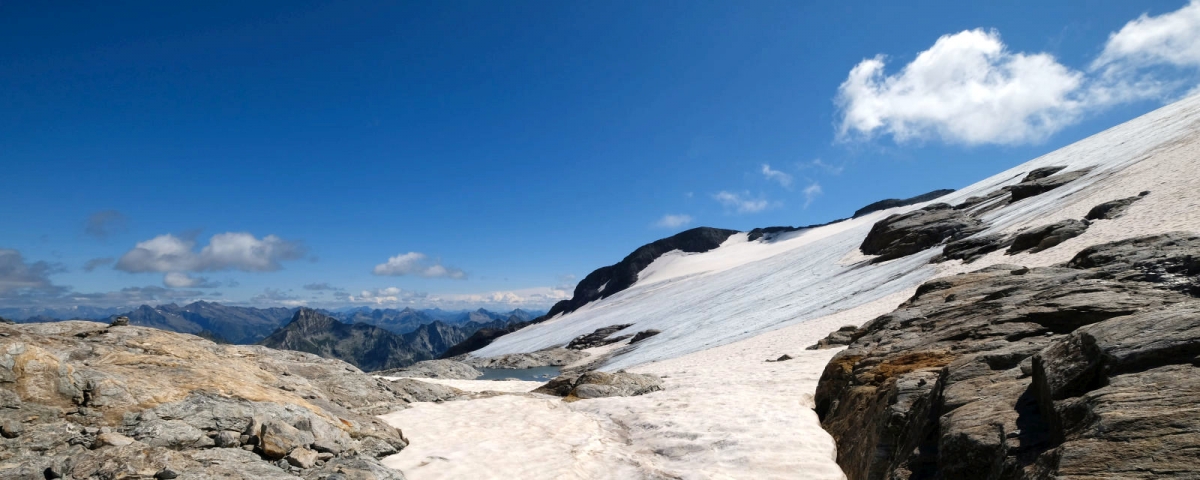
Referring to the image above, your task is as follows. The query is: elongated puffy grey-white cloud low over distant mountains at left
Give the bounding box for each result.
[116,232,306,272]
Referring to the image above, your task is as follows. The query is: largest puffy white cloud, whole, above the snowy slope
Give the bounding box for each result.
[838,29,1084,145]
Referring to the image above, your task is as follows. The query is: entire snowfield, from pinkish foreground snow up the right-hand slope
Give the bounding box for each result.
[384,96,1200,480]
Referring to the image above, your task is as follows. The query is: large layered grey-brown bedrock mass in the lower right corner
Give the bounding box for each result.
[816,233,1200,480]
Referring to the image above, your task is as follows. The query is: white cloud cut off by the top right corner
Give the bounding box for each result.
[1092,0,1200,68]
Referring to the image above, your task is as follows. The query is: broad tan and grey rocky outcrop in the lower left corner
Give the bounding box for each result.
[0,322,422,479]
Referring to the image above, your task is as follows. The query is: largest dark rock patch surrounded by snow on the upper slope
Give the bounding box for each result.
[859,203,984,262]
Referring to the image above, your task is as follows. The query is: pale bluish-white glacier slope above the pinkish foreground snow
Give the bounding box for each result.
[474,96,1200,370]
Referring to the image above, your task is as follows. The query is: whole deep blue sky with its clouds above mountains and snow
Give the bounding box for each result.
[0,0,1200,307]
